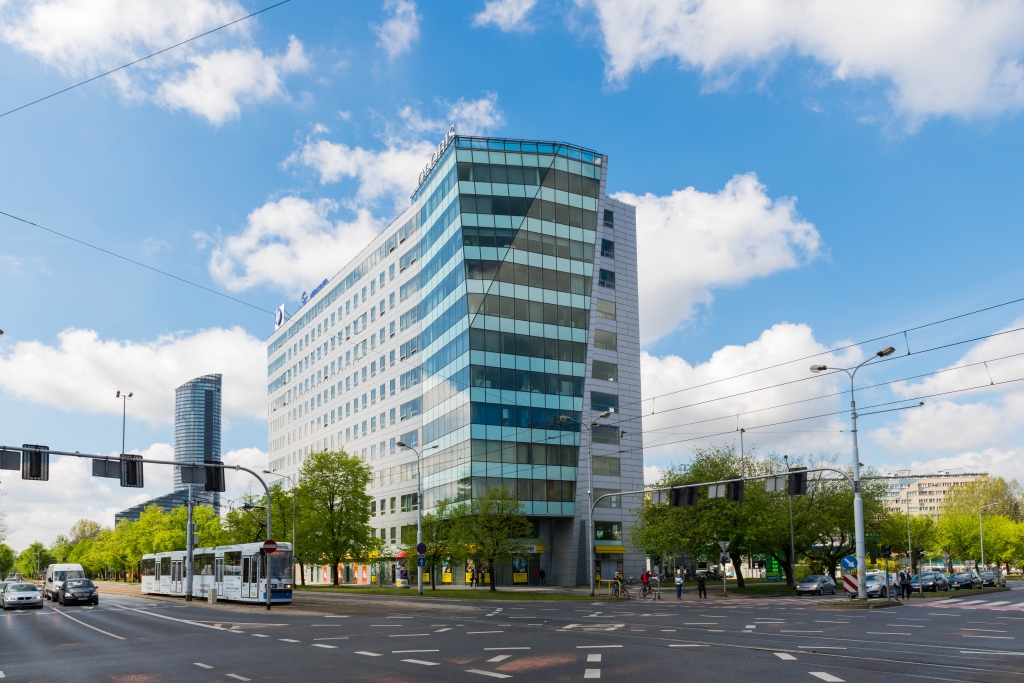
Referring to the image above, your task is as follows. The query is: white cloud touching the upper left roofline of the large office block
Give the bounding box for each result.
[209,197,384,294]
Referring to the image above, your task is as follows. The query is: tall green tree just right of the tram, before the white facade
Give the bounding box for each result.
[299,451,374,586]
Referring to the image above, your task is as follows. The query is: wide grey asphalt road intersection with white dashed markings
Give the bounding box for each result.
[0,591,1024,683]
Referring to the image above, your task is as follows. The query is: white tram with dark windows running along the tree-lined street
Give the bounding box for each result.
[142,543,293,604]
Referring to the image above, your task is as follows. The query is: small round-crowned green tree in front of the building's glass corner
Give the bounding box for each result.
[456,486,534,591]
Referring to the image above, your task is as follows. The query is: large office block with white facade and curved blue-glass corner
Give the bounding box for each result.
[267,133,643,585]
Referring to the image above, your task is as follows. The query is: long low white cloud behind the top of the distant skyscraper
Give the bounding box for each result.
[0,328,266,425]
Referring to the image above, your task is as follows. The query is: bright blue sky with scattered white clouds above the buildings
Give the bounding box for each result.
[0,0,1024,549]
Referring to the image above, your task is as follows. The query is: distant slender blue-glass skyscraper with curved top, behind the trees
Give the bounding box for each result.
[174,375,221,510]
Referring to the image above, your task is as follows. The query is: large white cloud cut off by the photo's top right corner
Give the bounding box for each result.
[578,0,1024,126]
